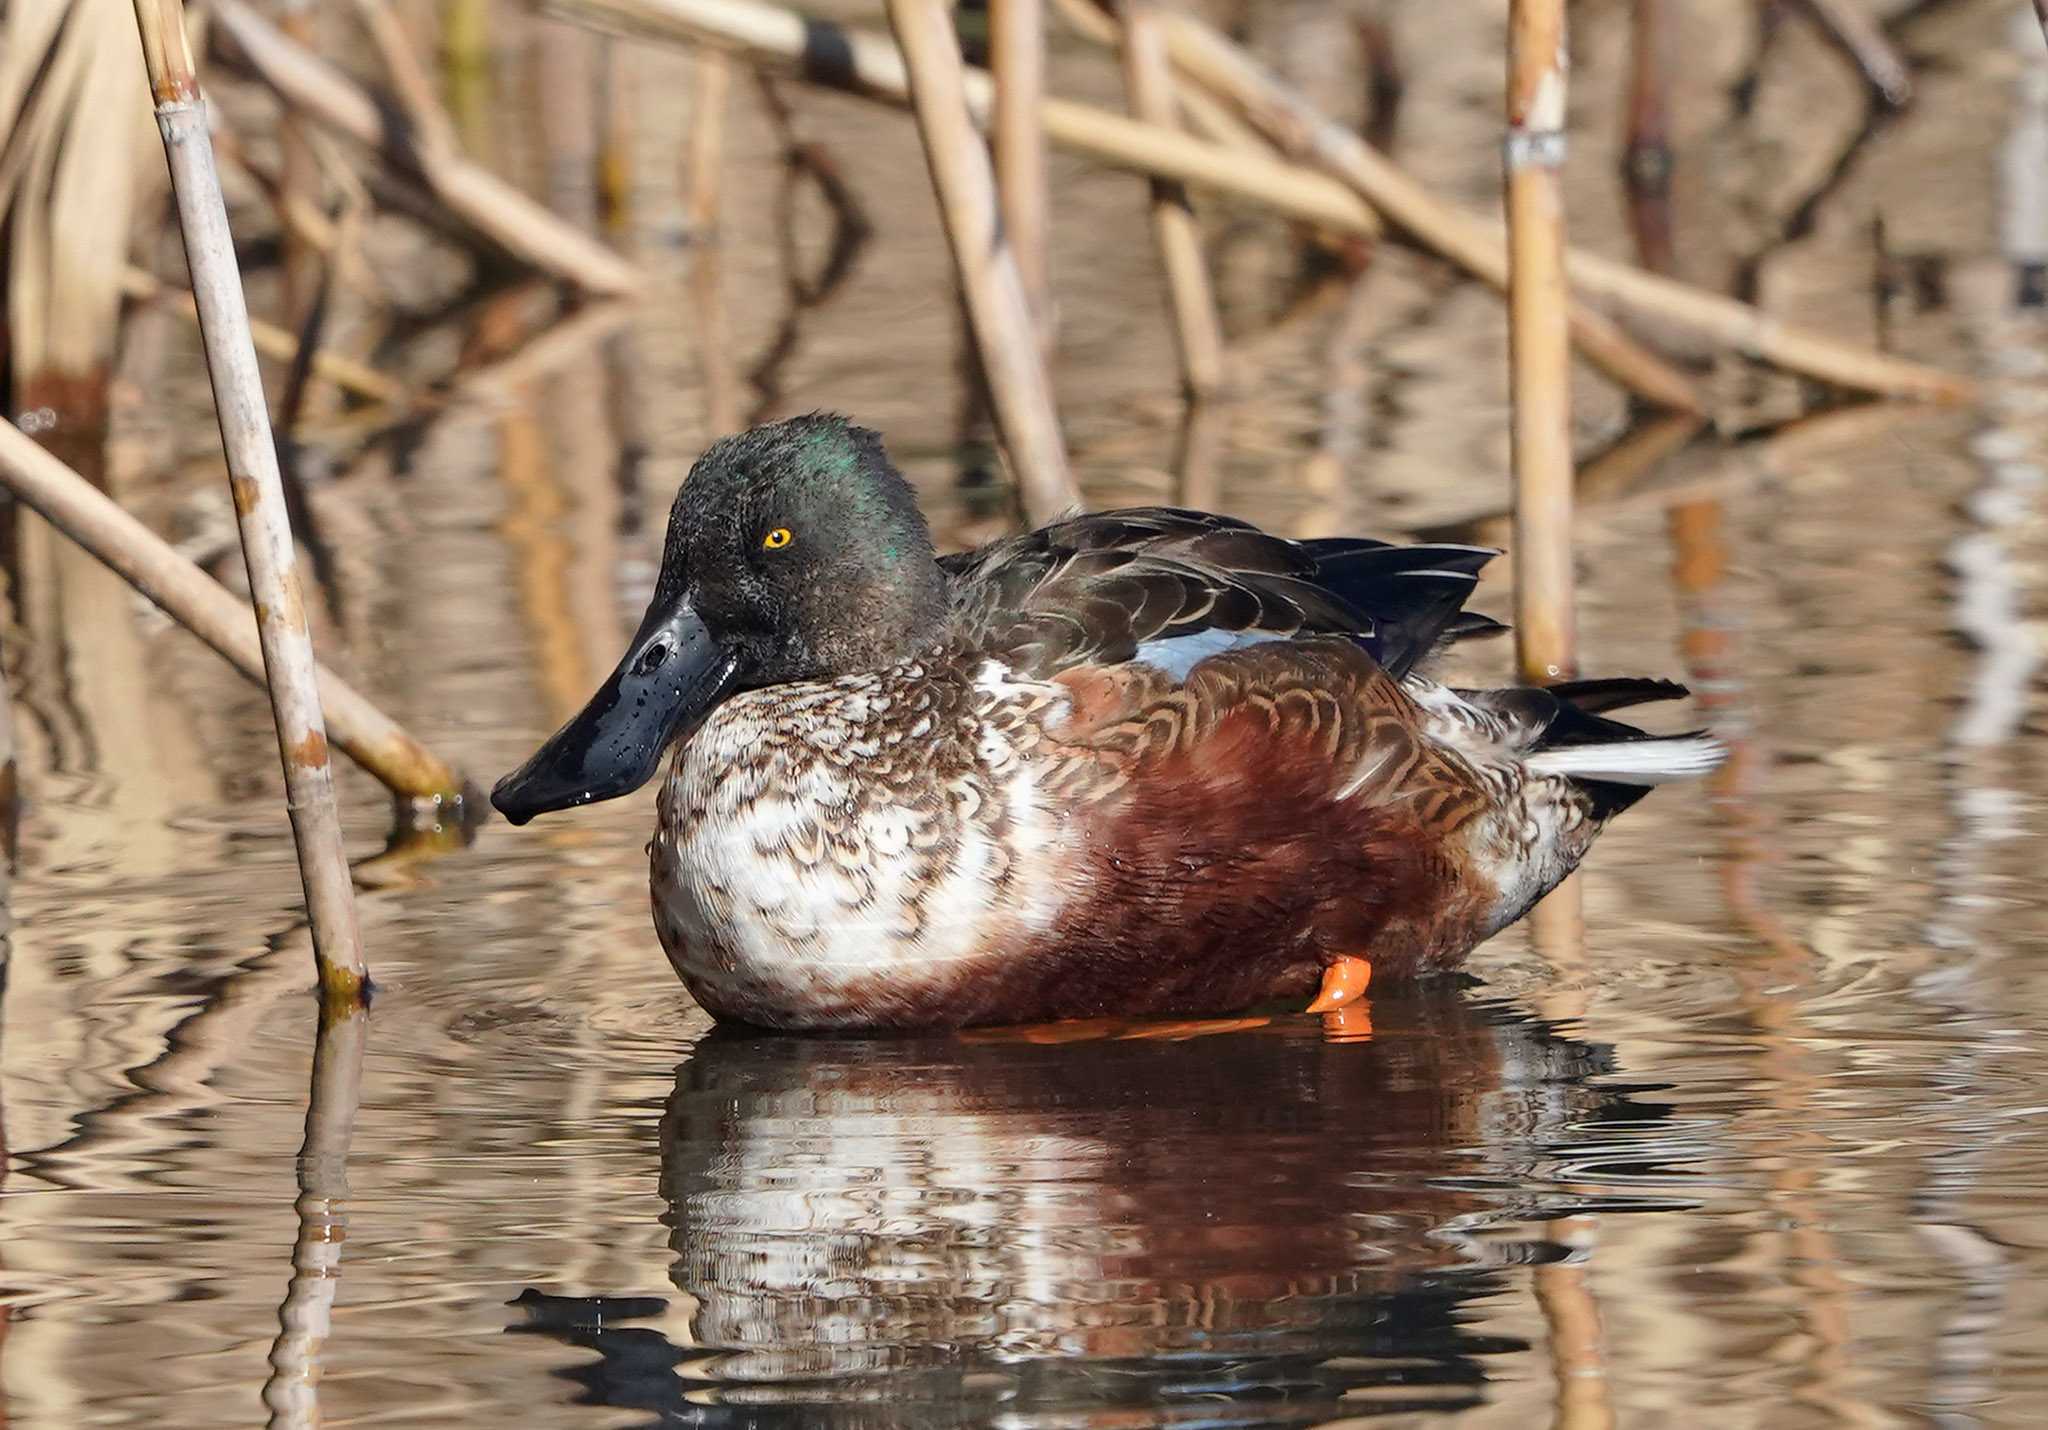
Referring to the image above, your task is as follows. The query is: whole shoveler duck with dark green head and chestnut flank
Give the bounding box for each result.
[492,416,1720,1028]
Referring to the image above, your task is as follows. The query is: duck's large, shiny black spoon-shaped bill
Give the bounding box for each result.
[492,596,739,824]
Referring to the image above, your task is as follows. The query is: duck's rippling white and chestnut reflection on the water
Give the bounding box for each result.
[520,990,1671,1426]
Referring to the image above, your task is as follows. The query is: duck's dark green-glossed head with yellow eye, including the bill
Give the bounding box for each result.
[492,414,946,824]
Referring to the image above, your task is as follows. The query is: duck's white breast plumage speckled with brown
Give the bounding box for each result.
[649,658,1065,1024]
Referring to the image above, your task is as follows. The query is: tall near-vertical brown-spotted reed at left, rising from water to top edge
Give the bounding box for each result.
[135,0,369,1006]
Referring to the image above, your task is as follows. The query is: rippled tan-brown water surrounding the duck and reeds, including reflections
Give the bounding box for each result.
[0,0,2048,1426]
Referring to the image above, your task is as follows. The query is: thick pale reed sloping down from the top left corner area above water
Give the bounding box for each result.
[213,0,641,293]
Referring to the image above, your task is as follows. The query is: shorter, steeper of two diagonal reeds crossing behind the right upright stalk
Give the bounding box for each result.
[1165,14,1704,412]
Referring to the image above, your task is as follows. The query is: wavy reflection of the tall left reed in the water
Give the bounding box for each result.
[262,1004,369,1430]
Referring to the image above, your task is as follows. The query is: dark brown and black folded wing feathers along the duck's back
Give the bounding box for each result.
[940,506,1499,678]
